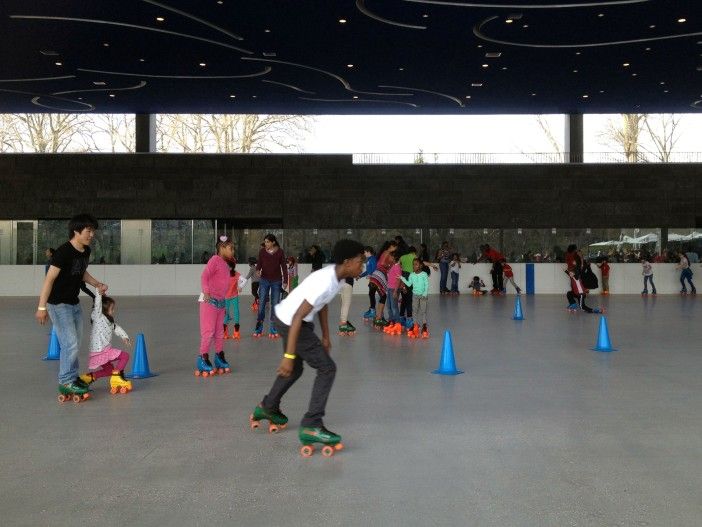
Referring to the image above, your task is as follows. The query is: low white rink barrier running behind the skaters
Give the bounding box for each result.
[0,263,702,296]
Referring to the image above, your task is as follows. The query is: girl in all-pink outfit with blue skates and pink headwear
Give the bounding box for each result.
[195,236,234,377]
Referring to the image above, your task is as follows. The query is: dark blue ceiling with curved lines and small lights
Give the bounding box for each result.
[0,0,702,114]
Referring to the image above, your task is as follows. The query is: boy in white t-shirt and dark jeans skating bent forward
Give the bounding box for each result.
[249,240,364,456]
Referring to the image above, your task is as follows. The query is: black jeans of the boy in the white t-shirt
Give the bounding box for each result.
[263,317,336,427]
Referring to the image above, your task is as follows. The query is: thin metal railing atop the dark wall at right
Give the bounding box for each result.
[353,152,702,165]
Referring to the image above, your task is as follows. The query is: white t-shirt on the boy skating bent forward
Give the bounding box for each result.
[275,265,344,326]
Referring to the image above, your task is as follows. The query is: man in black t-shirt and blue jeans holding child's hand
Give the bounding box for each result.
[35,214,107,396]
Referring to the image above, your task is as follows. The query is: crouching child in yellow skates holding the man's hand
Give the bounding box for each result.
[80,289,132,394]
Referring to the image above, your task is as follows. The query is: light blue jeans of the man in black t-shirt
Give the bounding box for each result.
[46,304,83,384]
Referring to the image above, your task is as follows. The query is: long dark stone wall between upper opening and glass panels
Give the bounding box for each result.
[0,154,702,228]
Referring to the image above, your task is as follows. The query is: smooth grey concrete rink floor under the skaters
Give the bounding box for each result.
[0,292,702,527]
